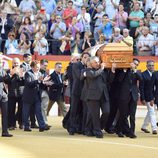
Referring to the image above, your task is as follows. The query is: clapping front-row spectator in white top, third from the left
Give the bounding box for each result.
[33,31,49,55]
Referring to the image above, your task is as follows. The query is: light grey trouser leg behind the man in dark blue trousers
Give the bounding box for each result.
[41,90,49,124]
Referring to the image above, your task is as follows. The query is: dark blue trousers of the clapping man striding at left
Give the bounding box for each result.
[23,101,45,129]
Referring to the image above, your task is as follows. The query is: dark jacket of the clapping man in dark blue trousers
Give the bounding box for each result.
[22,70,41,104]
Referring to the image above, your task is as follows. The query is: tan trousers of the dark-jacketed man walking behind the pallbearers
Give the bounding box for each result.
[47,97,67,117]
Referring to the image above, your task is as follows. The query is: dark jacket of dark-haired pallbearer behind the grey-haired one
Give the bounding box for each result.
[72,61,84,97]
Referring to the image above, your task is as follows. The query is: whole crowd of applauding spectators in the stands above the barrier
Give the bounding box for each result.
[0,0,158,56]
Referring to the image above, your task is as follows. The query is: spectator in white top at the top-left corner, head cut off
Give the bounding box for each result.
[0,0,18,14]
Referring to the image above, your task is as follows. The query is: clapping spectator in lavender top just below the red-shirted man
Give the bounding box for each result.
[68,17,83,38]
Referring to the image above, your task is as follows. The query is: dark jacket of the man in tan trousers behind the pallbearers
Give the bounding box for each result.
[49,71,64,101]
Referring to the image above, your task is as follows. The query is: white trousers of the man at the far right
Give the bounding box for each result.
[142,102,157,131]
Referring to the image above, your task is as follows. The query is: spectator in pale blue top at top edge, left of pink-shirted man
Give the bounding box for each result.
[105,0,120,20]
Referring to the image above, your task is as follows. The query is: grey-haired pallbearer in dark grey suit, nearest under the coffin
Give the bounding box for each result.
[84,57,115,138]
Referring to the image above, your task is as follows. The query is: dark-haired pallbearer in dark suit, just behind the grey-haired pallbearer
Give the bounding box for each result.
[68,53,90,135]
